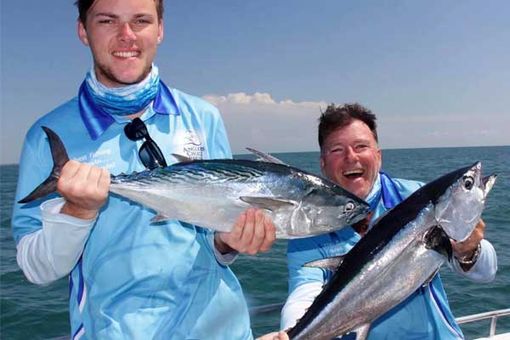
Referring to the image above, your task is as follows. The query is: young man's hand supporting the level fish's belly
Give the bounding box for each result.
[214,208,276,255]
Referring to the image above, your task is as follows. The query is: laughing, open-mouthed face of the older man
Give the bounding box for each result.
[321,119,381,199]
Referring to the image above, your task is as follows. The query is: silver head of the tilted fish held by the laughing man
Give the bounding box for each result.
[435,162,496,242]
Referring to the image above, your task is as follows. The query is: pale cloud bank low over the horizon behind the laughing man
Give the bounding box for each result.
[204,92,510,153]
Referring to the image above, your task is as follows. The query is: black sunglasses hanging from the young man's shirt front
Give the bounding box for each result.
[124,118,167,170]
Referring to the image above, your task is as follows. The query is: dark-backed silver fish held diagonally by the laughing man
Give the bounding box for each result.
[288,163,496,339]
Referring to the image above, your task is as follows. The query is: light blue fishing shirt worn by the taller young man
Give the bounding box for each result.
[12,82,253,340]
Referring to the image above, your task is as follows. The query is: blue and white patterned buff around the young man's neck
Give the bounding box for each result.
[85,64,159,116]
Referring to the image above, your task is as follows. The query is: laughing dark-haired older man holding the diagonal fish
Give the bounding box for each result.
[281,104,497,339]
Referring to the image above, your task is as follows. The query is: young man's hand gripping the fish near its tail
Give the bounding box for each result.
[57,160,110,219]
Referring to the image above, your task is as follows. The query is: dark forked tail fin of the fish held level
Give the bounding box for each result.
[18,126,69,203]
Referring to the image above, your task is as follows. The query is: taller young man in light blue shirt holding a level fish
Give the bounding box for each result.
[12,0,275,339]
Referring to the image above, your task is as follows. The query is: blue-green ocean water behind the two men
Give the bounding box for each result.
[0,146,510,339]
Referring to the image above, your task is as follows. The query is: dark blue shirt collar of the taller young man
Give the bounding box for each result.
[78,80,179,140]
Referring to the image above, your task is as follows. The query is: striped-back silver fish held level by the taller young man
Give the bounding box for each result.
[19,127,369,238]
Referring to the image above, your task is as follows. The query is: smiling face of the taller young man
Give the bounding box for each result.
[78,0,163,87]
